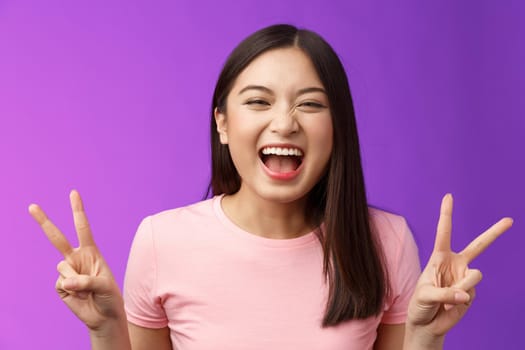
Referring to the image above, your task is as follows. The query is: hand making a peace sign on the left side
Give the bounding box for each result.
[29,191,126,332]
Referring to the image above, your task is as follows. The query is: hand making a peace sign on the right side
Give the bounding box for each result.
[407,194,512,342]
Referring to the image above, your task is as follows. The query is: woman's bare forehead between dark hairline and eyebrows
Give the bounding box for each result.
[232,47,323,92]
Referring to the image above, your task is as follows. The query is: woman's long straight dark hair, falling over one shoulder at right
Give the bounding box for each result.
[208,24,390,327]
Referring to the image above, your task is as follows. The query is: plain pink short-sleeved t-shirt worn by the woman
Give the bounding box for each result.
[124,196,420,350]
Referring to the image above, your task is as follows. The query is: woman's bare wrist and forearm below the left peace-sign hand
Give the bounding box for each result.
[89,316,131,350]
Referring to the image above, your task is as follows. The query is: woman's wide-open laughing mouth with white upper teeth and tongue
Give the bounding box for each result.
[259,146,303,177]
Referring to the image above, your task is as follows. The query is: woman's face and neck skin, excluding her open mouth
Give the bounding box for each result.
[214,47,333,239]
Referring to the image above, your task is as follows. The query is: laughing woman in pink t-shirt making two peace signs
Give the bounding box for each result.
[29,25,512,349]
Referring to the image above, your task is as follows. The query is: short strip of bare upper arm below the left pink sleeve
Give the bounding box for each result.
[128,322,173,350]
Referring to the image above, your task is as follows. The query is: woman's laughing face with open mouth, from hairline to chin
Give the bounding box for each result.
[215,48,333,203]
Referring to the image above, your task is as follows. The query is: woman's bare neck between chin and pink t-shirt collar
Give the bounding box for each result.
[221,185,314,239]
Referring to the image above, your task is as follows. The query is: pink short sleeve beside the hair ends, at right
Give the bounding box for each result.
[381,216,421,324]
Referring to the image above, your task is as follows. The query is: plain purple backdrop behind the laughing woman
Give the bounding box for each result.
[0,0,525,349]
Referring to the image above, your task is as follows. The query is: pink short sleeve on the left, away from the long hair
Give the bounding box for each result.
[124,217,168,328]
